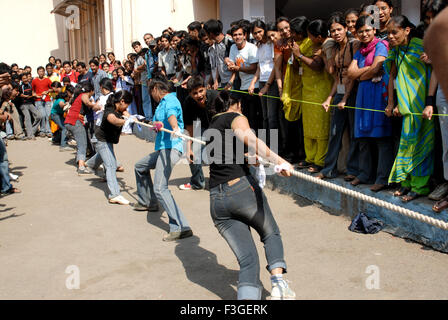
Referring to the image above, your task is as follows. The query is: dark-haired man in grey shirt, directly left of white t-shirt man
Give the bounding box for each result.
[204,19,232,90]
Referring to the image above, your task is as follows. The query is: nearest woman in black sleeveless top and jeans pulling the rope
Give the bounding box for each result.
[205,91,295,300]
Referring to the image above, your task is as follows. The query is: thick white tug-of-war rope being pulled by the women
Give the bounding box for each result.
[131,120,448,230]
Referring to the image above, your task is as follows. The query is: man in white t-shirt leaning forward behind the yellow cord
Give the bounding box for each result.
[225,25,262,131]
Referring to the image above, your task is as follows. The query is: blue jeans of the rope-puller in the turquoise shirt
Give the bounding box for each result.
[134,149,190,232]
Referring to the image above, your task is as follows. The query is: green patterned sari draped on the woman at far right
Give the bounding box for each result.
[385,38,434,183]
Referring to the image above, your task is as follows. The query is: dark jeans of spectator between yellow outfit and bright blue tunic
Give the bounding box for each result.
[321,94,359,178]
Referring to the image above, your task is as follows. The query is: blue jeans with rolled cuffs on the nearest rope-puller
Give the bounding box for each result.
[210,176,286,300]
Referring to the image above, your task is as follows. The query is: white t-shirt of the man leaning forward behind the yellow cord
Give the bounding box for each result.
[229,42,258,90]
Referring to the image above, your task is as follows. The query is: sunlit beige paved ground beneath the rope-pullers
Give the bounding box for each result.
[0,136,448,300]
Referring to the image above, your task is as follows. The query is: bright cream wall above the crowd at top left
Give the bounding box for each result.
[0,0,66,75]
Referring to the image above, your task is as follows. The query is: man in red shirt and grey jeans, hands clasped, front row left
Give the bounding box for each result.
[31,67,52,137]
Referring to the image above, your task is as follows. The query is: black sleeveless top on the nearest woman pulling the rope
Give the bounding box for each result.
[205,112,250,189]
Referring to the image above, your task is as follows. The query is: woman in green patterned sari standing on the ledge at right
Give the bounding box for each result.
[385,16,434,202]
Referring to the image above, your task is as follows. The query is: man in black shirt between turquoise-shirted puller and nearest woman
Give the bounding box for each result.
[179,75,218,190]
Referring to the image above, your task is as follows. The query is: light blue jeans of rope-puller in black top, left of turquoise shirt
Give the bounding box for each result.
[86,141,120,199]
